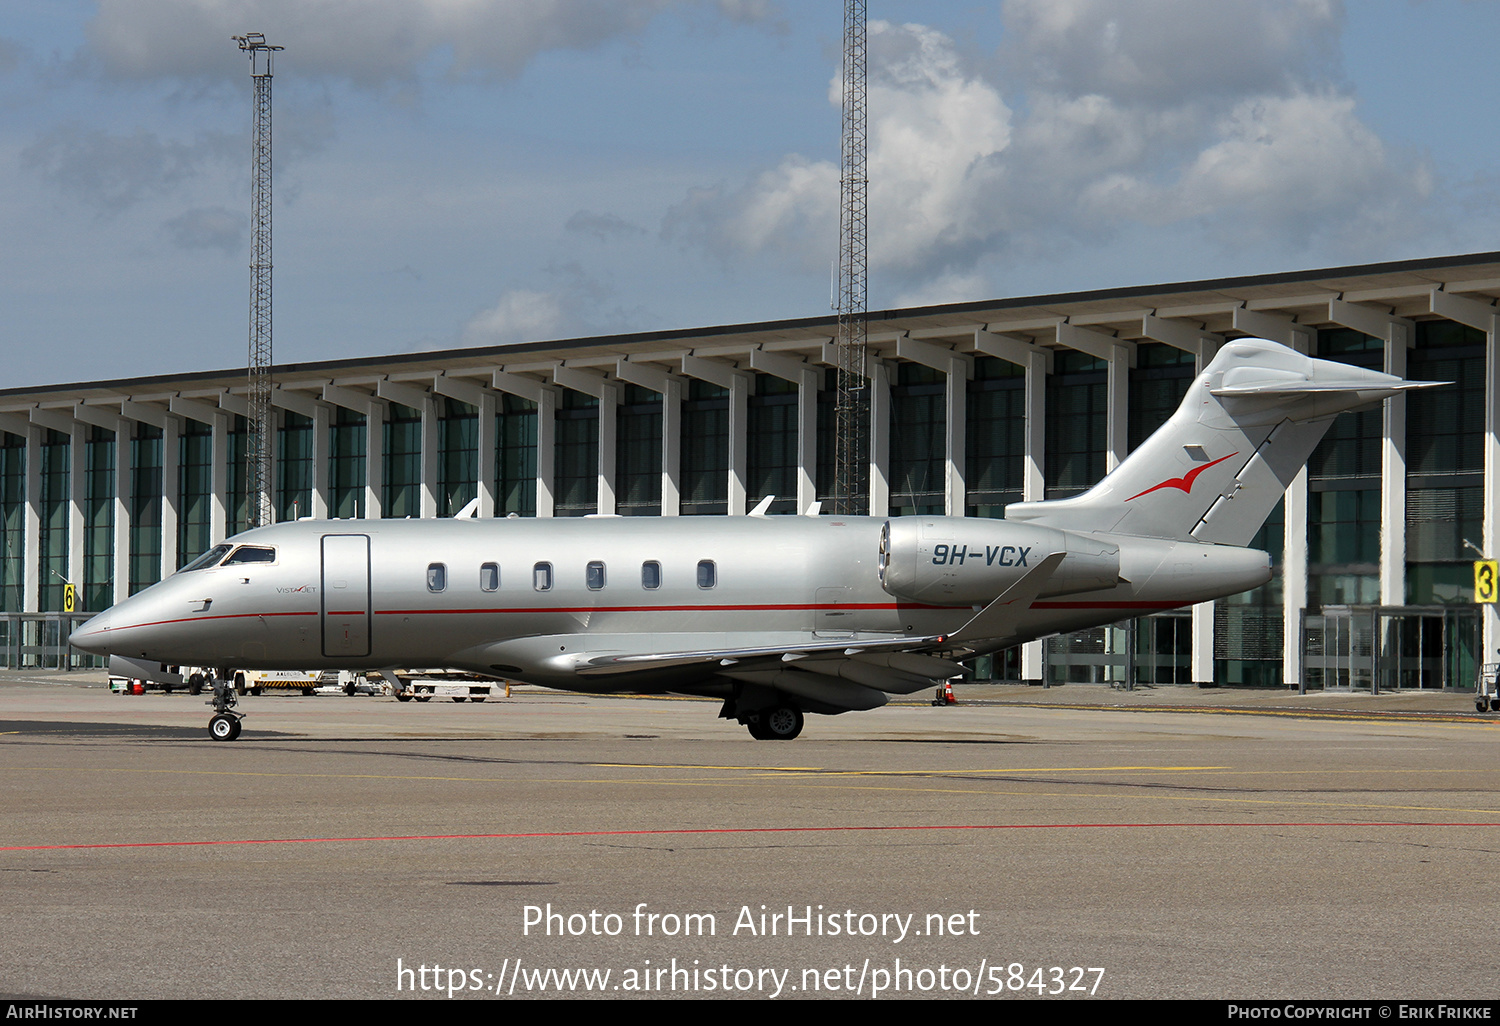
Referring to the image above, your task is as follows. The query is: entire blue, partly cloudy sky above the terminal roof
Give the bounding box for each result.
[0,0,1500,387]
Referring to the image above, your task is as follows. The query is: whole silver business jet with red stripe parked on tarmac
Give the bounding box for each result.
[72,339,1440,740]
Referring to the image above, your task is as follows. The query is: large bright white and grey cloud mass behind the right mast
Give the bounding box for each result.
[663,0,1431,302]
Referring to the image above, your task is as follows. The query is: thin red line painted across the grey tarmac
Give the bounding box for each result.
[0,821,1500,852]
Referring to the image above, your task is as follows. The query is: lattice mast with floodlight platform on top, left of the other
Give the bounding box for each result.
[233,32,284,528]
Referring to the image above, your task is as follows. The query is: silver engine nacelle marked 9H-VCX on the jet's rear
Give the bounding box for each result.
[881,516,1121,606]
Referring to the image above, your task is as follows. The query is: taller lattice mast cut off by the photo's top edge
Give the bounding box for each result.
[833,0,875,516]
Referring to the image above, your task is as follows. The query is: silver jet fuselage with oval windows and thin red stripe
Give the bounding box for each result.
[72,516,1269,690]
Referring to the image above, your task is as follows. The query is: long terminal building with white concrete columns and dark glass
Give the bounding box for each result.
[0,254,1500,689]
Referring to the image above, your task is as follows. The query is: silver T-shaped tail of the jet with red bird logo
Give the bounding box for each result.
[1005,339,1443,546]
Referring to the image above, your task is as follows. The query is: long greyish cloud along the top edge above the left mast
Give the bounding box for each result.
[89,0,776,86]
